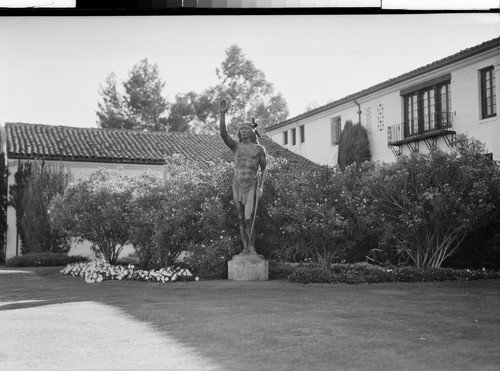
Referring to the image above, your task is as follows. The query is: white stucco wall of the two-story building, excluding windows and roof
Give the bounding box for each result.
[267,50,500,165]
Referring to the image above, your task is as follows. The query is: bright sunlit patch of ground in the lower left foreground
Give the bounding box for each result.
[0,269,216,371]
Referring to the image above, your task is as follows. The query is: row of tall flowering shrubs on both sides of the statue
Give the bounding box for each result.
[51,137,500,274]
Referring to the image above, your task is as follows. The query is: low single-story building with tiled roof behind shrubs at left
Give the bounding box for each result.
[1,123,314,259]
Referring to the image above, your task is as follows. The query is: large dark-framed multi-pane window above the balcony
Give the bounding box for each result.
[404,81,451,137]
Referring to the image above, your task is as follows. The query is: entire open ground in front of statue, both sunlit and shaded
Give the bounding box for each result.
[0,267,500,370]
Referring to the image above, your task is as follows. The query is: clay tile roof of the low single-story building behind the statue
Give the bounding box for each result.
[5,123,315,168]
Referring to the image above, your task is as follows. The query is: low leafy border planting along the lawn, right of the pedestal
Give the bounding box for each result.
[289,264,500,284]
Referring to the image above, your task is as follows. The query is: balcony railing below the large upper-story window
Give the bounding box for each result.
[387,112,454,146]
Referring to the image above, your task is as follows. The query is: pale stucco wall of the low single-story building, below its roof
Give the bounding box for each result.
[5,160,163,259]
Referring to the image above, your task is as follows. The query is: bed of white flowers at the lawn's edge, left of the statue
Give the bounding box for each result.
[61,260,199,283]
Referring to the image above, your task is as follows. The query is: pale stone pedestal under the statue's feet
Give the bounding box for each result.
[227,255,269,281]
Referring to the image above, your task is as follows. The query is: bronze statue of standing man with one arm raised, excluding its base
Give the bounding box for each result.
[220,100,267,255]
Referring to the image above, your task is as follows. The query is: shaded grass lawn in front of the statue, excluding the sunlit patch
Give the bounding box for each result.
[0,268,500,370]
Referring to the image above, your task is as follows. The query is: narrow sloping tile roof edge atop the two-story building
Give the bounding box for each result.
[267,37,500,130]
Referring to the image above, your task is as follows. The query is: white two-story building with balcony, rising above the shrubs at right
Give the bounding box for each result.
[267,38,500,165]
